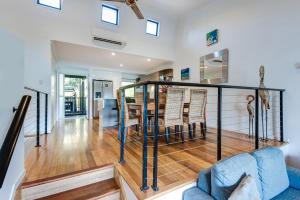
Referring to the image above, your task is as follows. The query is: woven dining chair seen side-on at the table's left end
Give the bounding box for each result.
[117,90,141,143]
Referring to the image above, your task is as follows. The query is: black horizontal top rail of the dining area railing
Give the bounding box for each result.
[120,81,285,92]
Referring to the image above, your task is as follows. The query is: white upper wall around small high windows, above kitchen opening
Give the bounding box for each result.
[0,0,176,130]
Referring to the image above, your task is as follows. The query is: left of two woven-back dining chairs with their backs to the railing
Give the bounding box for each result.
[160,88,185,144]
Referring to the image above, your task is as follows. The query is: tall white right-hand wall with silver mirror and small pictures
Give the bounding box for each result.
[175,0,300,166]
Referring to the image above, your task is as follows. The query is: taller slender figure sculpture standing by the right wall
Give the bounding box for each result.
[259,66,270,141]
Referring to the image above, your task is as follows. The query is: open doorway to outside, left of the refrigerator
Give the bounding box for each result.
[64,75,87,117]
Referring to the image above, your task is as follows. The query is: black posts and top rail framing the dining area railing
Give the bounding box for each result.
[120,81,285,191]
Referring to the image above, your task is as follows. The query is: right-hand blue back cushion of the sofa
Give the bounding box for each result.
[253,147,289,200]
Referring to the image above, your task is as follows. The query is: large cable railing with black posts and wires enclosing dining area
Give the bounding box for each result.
[120,81,285,191]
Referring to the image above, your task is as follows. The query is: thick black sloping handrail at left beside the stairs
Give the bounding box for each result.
[0,95,31,188]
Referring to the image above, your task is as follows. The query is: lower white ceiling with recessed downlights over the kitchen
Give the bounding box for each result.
[52,41,172,74]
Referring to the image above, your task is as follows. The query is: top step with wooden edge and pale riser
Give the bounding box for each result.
[21,165,114,200]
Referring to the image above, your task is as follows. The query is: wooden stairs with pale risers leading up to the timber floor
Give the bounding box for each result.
[21,165,120,200]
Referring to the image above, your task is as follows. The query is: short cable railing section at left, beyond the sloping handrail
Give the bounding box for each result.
[24,87,48,147]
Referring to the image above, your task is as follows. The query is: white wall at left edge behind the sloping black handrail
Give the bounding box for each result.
[0,28,24,200]
